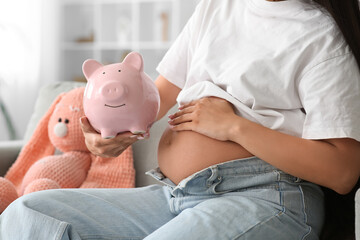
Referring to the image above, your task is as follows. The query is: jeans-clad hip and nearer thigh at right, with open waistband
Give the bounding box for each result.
[146,159,324,240]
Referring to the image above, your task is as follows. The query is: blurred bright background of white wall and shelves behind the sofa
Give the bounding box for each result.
[0,0,199,141]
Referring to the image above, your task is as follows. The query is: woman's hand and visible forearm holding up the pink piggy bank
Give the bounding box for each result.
[80,75,181,157]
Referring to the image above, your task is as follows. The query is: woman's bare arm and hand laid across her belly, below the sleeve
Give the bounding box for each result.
[170,98,360,194]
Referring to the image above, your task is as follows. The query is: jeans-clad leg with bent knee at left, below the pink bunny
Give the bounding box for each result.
[0,185,174,240]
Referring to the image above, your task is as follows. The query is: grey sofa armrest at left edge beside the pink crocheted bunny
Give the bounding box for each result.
[0,140,24,176]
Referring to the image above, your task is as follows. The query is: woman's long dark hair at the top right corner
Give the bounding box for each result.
[314,0,360,67]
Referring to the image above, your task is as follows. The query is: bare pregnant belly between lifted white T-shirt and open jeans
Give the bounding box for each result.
[158,128,253,184]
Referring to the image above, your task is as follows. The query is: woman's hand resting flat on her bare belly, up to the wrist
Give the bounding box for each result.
[169,97,238,141]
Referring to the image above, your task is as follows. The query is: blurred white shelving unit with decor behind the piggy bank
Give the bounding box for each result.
[59,0,198,81]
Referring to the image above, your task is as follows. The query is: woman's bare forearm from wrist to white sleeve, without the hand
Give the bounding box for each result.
[229,117,360,194]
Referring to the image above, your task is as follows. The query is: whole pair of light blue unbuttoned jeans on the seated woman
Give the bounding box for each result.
[0,157,324,240]
